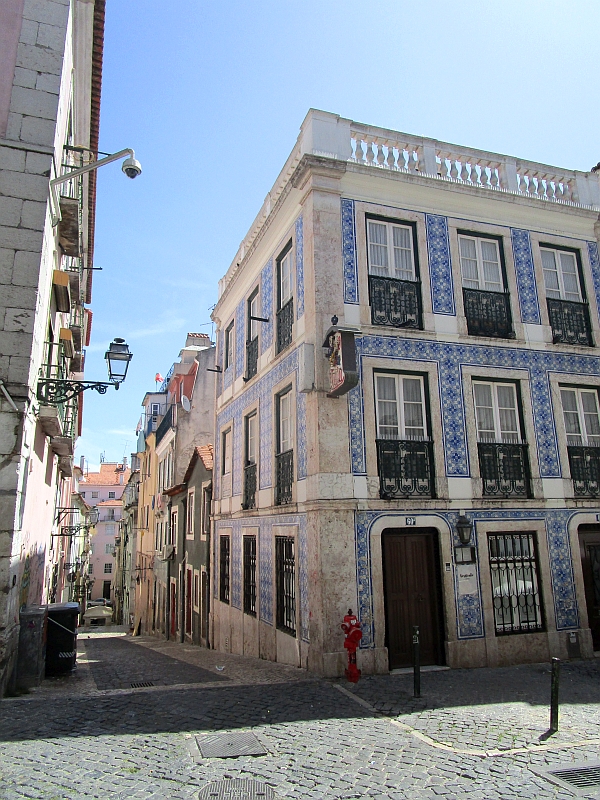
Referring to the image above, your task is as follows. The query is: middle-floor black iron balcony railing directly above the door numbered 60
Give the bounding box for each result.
[377,439,435,500]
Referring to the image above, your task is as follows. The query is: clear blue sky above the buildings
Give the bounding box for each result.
[78,0,600,466]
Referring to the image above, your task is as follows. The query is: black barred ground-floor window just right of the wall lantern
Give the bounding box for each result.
[488,532,543,635]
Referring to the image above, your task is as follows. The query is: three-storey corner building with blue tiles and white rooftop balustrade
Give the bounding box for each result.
[211,110,600,676]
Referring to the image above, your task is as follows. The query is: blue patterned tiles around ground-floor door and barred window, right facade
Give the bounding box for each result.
[355,509,579,649]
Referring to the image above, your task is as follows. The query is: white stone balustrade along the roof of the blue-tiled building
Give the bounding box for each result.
[219,109,600,295]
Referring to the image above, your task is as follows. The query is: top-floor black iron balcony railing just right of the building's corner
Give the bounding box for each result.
[369,275,422,328]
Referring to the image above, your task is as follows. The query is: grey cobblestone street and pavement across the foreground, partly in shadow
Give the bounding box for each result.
[0,633,600,800]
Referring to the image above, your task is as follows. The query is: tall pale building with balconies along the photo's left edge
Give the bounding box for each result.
[0,0,104,696]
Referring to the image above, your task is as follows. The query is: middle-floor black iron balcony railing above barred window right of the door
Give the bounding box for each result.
[477,442,531,497]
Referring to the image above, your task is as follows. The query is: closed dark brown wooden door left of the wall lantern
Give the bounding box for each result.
[382,528,444,669]
